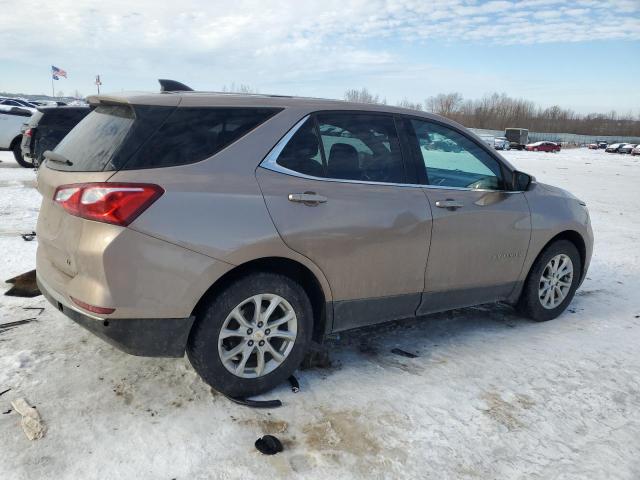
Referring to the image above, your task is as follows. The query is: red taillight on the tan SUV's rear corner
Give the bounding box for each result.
[53,183,164,227]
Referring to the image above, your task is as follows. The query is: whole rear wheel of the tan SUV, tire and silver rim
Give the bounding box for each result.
[187,272,313,397]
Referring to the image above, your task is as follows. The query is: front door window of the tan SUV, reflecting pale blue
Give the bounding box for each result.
[411,120,504,190]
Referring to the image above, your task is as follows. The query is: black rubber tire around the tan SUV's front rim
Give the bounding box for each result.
[516,240,582,322]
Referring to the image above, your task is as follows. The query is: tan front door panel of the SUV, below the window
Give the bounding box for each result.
[421,187,531,312]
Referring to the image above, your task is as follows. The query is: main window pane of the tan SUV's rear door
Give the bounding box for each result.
[318,113,404,183]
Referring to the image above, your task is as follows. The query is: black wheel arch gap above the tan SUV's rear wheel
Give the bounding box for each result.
[193,257,333,342]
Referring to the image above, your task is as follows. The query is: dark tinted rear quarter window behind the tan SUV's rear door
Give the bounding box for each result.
[124,108,278,170]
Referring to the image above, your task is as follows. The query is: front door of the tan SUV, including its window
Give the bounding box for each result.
[404,119,531,313]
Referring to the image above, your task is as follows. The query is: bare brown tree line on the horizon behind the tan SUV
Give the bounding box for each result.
[344,88,640,136]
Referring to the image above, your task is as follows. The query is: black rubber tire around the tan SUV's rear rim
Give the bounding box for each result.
[187,272,313,398]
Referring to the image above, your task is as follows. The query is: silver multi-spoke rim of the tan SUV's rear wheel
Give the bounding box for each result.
[218,293,298,378]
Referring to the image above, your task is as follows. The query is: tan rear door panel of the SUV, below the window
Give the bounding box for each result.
[256,168,431,330]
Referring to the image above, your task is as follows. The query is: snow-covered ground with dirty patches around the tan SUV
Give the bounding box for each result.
[0,149,640,480]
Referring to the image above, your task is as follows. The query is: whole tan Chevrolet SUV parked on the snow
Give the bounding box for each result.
[37,81,593,396]
